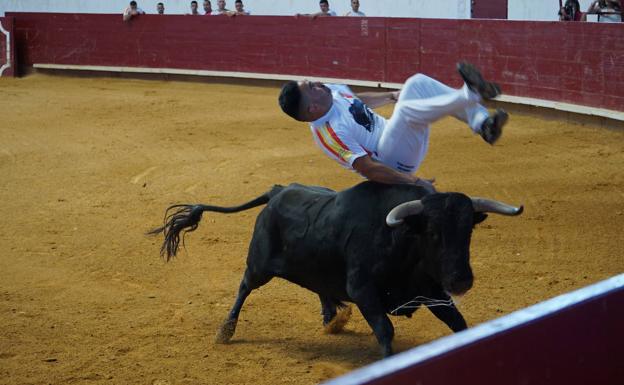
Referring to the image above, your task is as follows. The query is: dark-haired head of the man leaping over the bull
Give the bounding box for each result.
[279,80,333,122]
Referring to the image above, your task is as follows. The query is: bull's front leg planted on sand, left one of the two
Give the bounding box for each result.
[347,279,394,357]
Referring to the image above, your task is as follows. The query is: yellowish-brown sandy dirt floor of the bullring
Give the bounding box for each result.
[0,74,624,385]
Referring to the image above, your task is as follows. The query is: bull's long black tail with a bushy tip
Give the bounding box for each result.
[148,185,284,262]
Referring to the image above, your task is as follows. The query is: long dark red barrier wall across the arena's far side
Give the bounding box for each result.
[7,13,624,111]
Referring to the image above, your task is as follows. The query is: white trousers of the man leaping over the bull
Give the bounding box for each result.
[377,74,489,173]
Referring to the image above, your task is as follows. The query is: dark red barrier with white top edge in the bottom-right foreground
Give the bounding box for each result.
[326,275,624,385]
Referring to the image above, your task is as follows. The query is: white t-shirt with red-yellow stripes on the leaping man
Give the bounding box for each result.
[310,84,386,169]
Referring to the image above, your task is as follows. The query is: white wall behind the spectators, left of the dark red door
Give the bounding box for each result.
[0,0,470,19]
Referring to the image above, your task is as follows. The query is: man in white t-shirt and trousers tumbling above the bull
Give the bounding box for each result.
[279,63,508,189]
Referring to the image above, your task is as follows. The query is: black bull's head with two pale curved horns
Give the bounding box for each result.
[386,193,523,295]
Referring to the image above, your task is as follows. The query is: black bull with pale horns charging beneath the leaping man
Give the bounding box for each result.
[152,182,522,355]
